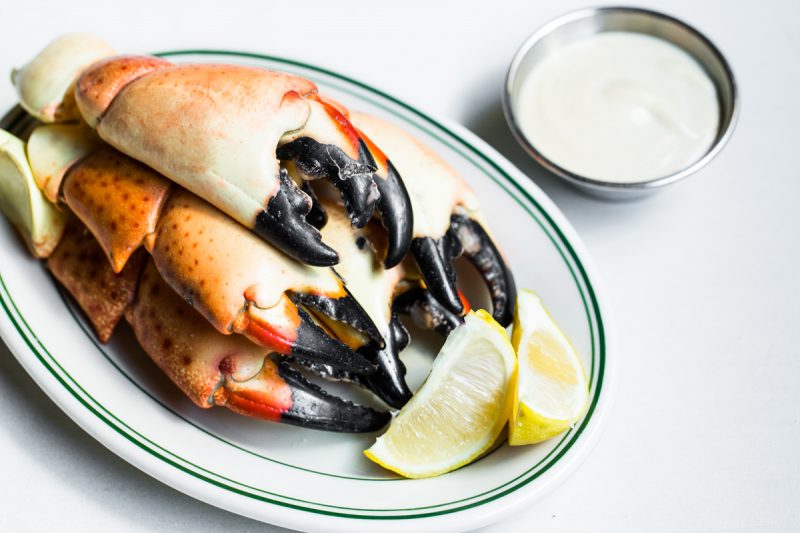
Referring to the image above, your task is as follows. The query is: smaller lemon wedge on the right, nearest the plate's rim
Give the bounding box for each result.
[508,290,589,446]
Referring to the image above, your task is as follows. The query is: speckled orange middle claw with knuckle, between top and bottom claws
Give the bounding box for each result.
[53,141,383,373]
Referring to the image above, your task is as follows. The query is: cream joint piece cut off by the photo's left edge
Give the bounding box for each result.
[0,130,66,257]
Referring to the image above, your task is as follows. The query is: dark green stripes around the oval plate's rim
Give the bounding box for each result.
[0,50,605,520]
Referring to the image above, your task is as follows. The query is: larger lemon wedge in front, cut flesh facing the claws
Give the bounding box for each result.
[364,310,516,478]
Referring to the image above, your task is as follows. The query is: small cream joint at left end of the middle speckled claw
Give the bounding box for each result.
[27,122,100,204]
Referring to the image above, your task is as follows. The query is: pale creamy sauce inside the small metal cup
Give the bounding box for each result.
[517,32,719,182]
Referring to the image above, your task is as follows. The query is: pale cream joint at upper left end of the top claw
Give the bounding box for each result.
[11,33,115,122]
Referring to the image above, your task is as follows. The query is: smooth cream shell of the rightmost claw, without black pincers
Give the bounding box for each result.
[350,112,485,239]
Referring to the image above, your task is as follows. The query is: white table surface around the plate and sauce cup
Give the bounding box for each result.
[0,0,800,532]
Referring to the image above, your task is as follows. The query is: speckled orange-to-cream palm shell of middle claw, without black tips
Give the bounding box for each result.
[147,189,345,333]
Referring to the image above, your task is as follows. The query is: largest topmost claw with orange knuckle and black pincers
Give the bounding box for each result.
[57,48,410,266]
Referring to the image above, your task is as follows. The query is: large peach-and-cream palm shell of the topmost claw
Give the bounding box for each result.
[91,65,316,228]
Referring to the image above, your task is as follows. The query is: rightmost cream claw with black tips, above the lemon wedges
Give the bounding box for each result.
[351,113,516,326]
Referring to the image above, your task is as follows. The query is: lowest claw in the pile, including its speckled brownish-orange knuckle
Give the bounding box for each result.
[47,217,389,432]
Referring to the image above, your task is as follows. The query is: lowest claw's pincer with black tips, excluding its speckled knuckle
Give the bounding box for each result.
[126,263,389,432]
